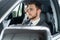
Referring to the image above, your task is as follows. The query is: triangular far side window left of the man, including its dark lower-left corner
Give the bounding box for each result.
[6,3,22,20]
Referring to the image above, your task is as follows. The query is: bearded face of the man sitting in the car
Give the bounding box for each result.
[25,4,39,19]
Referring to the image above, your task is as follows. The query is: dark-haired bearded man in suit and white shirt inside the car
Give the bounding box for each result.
[23,0,48,26]
